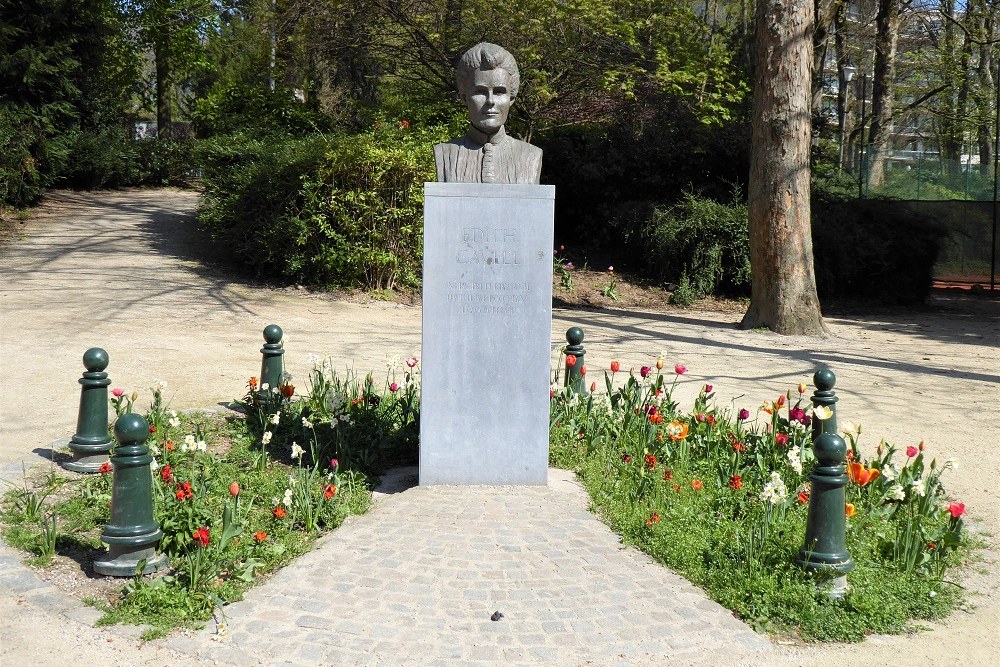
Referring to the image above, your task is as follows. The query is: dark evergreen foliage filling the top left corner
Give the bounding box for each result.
[0,0,138,206]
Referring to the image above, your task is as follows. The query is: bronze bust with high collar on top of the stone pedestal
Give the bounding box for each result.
[434,42,542,183]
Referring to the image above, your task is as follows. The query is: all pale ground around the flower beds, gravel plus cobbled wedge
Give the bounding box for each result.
[0,190,1000,665]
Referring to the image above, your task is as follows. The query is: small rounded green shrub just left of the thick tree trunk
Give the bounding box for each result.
[632,192,750,301]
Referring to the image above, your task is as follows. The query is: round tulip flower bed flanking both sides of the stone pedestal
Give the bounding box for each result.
[0,357,971,640]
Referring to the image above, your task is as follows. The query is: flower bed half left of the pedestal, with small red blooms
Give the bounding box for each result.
[0,359,417,638]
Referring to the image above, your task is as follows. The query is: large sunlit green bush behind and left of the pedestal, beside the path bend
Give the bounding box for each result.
[199,122,446,290]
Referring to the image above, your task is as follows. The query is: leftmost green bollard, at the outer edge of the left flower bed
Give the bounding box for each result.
[61,347,111,473]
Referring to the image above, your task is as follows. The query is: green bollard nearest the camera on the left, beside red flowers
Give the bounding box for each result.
[94,412,167,577]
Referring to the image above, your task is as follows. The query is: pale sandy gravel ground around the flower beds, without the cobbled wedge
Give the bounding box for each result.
[0,189,1000,665]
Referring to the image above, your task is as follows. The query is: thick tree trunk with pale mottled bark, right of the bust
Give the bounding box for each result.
[741,0,827,336]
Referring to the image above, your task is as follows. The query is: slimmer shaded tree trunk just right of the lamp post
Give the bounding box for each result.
[868,0,899,187]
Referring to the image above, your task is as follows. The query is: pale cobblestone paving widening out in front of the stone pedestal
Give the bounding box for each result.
[0,468,773,667]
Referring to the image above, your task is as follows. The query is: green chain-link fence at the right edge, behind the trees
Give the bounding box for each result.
[858,151,1000,289]
